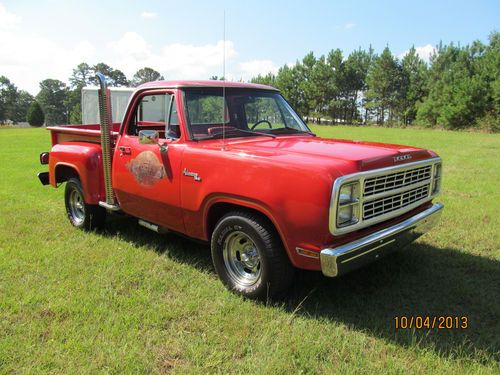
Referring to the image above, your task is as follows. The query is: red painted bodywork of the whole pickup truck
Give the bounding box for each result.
[49,81,436,270]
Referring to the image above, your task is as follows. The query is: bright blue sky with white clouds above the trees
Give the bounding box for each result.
[0,0,500,95]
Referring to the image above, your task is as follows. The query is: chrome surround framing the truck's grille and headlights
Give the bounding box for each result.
[328,157,442,236]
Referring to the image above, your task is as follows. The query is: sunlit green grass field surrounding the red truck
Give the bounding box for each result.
[0,126,500,374]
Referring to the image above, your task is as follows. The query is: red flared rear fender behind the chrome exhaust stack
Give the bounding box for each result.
[49,142,105,204]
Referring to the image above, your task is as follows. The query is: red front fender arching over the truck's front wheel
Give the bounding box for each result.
[181,147,338,269]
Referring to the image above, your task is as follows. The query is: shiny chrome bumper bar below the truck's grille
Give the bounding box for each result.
[320,203,444,277]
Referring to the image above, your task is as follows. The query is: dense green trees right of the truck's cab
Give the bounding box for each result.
[251,32,500,131]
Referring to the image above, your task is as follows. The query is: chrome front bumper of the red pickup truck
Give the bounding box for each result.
[320,203,444,277]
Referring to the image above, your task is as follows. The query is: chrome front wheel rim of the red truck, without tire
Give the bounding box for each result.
[222,231,261,287]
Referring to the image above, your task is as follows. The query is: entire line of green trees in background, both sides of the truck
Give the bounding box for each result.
[0,32,500,131]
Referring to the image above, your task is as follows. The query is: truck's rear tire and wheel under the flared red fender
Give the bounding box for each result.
[64,178,106,230]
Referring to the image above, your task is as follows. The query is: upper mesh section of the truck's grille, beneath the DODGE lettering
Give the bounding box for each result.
[363,165,432,197]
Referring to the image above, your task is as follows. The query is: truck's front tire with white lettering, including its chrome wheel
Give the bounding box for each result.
[211,211,294,300]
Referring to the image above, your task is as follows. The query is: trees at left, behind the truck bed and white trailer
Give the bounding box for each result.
[0,62,164,126]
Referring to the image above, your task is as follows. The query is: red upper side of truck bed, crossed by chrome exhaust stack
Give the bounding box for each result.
[47,122,120,146]
